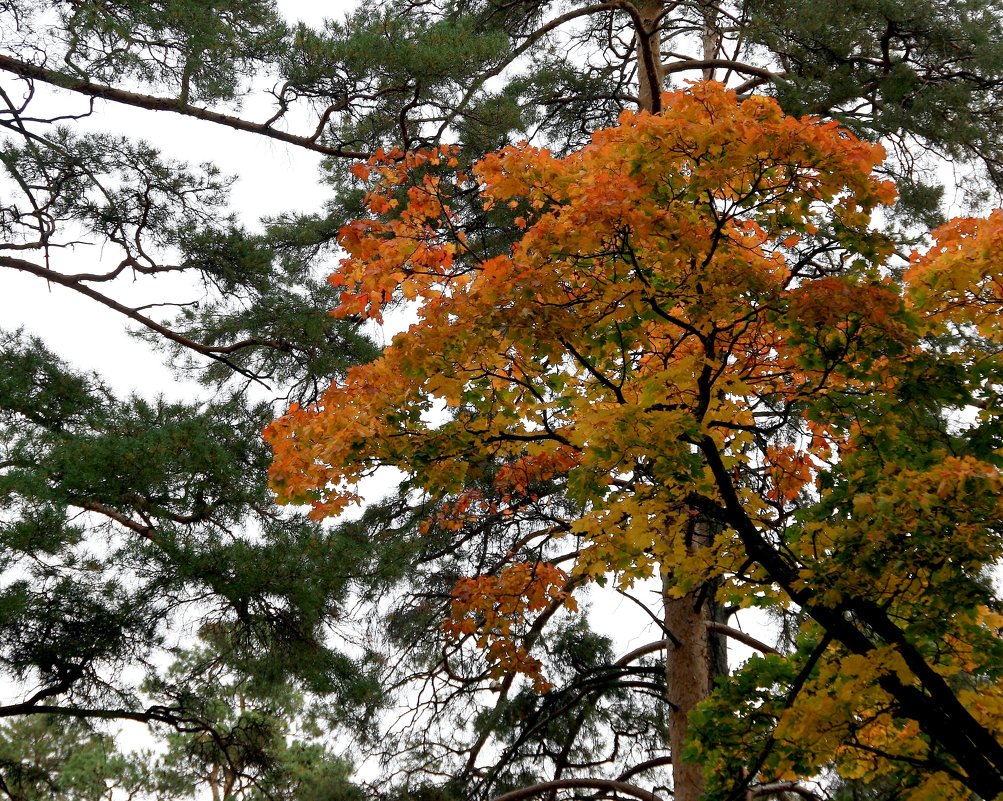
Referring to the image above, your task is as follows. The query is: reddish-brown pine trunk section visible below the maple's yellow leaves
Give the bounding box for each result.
[662,518,727,801]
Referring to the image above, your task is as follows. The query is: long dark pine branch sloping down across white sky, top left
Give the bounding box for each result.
[0,54,370,159]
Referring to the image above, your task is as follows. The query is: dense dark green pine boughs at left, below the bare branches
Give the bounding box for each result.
[0,326,374,723]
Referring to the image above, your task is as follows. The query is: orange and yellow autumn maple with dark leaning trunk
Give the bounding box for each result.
[266,84,1003,798]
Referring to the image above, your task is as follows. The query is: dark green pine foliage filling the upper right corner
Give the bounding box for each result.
[746,0,1003,223]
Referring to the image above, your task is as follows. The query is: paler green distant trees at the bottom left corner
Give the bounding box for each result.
[0,650,361,801]
